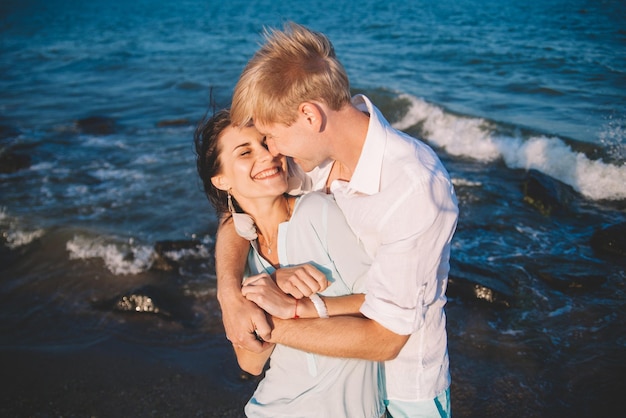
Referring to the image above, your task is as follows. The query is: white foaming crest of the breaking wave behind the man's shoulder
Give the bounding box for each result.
[394,95,626,200]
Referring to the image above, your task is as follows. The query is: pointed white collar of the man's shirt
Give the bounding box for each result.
[348,94,389,195]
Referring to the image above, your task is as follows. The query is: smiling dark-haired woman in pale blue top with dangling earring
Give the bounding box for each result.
[195,110,384,417]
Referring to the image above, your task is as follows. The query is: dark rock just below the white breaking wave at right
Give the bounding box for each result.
[522,170,577,216]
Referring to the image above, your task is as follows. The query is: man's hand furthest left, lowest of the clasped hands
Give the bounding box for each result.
[219,293,272,353]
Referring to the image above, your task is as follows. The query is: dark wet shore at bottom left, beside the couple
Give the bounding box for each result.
[0,341,256,418]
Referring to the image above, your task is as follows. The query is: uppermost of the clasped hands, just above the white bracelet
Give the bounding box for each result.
[274,264,330,299]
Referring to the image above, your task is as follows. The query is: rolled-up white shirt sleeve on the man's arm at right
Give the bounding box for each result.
[361,178,458,335]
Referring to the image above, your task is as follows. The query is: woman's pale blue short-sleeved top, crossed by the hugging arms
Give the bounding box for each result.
[245,192,384,418]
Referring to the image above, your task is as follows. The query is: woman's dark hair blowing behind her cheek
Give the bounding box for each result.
[193,109,241,214]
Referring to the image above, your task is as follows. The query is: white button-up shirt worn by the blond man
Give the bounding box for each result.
[310,95,458,401]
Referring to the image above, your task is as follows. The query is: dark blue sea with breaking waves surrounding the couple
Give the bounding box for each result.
[0,0,626,416]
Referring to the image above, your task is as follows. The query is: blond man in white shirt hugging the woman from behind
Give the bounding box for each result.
[216,23,458,417]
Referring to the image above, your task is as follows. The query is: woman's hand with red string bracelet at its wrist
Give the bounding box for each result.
[241,273,297,319]
